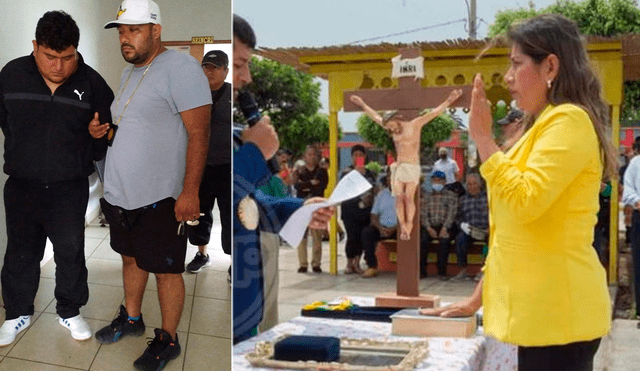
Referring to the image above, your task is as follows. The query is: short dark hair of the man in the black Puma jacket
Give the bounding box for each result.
[36,10,80,53]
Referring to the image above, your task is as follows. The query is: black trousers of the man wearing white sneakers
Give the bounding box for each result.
[1,177,89,319]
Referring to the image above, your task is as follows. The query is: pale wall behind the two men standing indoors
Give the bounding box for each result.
[0,0,231,264]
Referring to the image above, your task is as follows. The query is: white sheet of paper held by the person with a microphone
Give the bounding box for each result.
[280,170,372,247]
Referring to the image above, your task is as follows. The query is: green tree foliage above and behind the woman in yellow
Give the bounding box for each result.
[488,0,640,124]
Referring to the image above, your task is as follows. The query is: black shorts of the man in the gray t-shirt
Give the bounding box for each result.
[100,198,187,274]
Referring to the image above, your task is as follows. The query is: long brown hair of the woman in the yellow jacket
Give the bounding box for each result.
[506,14,618,179]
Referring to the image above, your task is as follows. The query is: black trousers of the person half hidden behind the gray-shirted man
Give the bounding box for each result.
[189,164,231,255]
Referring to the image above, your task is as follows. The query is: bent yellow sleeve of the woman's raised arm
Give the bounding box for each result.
[480,105,601,223]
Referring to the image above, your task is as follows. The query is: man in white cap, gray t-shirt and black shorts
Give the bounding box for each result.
[96,0,211,370]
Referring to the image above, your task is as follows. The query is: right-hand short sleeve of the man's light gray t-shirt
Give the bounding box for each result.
[169,55,211,113]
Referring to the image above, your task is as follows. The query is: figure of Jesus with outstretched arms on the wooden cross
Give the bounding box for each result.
[349,89,462,241]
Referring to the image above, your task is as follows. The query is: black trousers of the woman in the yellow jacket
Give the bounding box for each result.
[518,339,600,371]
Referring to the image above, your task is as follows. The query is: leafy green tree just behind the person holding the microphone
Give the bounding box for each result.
[234,57,340,154]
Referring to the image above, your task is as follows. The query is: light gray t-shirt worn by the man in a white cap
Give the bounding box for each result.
[104,50,211,211]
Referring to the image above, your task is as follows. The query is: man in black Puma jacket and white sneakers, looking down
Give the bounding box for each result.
[0,11,113,346]
